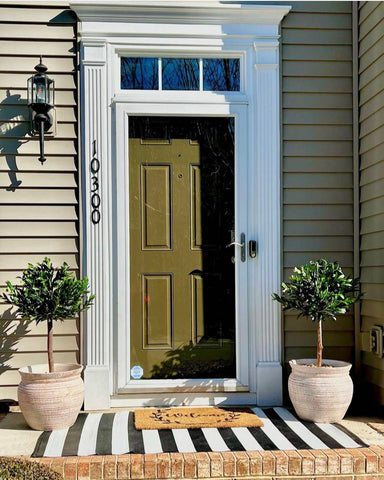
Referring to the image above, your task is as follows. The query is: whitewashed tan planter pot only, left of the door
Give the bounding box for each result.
[17,363,84,430]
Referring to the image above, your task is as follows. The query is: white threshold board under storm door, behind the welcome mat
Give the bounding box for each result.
[110,392,256,408]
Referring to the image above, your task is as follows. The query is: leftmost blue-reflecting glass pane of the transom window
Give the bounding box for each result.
[121,57,159,90]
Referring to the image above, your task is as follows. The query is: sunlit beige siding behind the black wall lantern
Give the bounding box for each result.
[0,2,80,399]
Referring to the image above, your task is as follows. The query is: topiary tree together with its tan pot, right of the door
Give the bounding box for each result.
[272,259,360,423]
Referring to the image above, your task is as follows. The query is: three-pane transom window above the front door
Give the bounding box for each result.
[121,57,240,92]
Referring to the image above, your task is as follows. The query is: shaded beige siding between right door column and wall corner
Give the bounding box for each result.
[281,2,354,363]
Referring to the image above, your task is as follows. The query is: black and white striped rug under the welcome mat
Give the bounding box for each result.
[32,407,367,457]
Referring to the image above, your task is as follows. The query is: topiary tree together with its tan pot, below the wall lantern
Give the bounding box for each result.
[3,258,94,430]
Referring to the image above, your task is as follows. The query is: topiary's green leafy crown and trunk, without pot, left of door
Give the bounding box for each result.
[3,257,95,372]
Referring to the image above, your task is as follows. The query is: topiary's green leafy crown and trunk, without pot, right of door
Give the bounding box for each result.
[272,259,360,367]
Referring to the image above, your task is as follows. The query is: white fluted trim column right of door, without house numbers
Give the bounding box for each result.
[253,38,282,406]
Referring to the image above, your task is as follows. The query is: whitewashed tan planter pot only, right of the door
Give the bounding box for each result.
[288,358,353,423]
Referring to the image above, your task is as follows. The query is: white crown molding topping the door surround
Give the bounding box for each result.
[69,0,291,25]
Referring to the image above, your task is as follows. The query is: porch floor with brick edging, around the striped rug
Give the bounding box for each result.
[0,412,384,480]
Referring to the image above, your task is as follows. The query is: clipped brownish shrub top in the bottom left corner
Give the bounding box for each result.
[0,457,63,480]
